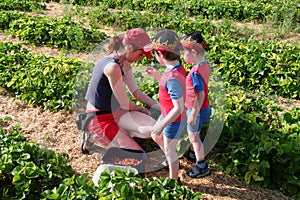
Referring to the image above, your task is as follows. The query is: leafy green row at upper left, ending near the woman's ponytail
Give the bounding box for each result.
[0,11,107,51]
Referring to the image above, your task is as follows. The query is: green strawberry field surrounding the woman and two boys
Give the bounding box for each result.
[0,0,300,199]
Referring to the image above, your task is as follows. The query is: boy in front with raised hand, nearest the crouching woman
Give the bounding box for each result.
[144,30,186,184]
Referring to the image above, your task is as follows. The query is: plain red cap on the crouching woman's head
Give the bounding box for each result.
[125,28,153,58]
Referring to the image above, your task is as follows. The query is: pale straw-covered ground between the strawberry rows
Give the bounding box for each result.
[0,3,299,200]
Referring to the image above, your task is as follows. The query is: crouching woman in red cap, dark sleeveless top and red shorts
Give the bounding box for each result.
[83,28,159,150]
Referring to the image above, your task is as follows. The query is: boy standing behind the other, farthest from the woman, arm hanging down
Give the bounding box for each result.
[181,32,210,178]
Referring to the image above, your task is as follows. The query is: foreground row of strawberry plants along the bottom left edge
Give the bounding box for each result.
[0,117,202,200]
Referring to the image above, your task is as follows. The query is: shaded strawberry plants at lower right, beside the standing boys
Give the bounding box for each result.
[214,88,300,198]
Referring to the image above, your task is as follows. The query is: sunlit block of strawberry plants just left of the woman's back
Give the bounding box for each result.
[0,42,82,110]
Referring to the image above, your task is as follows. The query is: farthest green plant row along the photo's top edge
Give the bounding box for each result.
[60,0,300,27]
